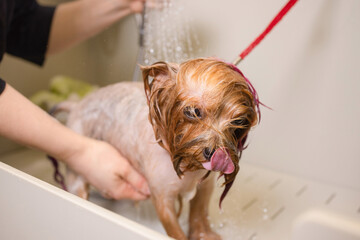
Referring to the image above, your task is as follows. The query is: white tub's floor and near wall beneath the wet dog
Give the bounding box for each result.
[0,150,360,240]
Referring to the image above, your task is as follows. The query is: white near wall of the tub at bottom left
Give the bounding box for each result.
[0,151,170,240]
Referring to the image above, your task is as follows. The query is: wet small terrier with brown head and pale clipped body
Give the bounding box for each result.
[59,58,259,239]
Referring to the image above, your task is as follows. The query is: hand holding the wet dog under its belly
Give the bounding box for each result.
[66,138,150,200]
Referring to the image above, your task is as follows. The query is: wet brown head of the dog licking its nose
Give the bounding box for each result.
[142,58,258,203]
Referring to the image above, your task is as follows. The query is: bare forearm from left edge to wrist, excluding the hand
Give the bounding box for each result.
[0,85,84,159]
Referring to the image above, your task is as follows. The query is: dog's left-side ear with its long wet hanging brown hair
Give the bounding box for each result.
[141,62,178,151]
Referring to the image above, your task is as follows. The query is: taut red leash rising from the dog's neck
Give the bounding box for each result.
[233,0,298,66]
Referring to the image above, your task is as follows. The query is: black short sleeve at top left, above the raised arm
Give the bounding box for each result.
[6,0,55,65]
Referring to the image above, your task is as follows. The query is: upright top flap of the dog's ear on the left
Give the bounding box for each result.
[141,62,178,102]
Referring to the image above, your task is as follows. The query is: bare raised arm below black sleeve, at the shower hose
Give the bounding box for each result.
[47,0,145,55]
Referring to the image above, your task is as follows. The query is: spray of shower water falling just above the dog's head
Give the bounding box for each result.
[140,0,202,63]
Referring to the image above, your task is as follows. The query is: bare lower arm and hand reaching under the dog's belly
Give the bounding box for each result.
[0,84,149,200]
